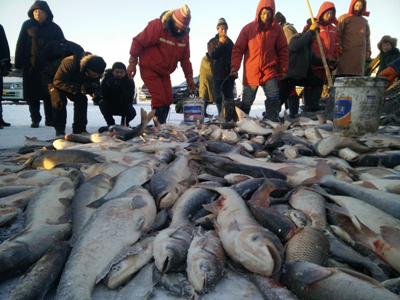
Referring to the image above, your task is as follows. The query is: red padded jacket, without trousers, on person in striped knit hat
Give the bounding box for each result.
[130,10,193,76]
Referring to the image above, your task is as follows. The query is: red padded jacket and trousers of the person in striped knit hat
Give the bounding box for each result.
[130,10,193,108]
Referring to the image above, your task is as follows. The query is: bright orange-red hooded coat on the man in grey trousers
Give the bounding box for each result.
[231,0,289,86]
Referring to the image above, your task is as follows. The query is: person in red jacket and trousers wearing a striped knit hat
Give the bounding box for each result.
[127,4,196,124]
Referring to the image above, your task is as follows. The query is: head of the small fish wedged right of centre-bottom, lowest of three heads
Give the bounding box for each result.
[187,254,223,292]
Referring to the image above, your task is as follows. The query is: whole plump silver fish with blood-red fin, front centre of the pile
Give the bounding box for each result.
[205,188,283,276]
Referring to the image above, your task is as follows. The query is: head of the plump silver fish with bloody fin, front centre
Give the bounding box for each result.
[234,227,283,276]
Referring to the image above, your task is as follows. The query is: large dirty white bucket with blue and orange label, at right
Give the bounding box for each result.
[333,77,387,137]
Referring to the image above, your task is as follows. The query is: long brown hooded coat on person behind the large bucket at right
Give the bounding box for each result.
[336,0,371,76]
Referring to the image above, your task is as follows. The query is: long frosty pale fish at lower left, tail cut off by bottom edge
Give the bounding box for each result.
[57,186,156,300]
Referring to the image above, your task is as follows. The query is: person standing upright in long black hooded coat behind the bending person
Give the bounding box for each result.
[15,1,64,128]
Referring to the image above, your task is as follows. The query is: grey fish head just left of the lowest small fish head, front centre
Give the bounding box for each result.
[153,228,192,273]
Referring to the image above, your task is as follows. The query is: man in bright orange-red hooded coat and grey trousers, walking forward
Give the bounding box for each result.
[231,0,289,121]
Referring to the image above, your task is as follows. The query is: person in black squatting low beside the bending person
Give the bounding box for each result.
[99,62,136,126]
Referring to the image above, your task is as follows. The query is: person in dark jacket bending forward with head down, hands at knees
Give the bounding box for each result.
[49,53,106,136]
